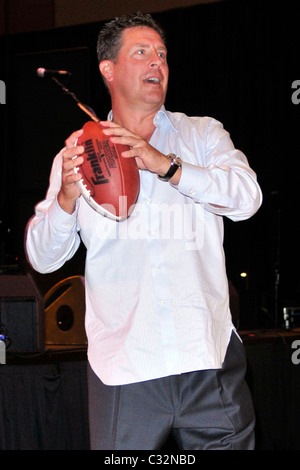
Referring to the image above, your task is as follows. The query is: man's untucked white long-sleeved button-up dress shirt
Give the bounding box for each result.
[26,107,262,385]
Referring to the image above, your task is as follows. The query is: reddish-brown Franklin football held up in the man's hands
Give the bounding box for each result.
[74,121,140,221]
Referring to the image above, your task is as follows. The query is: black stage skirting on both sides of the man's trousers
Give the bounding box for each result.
[0,344,300,452]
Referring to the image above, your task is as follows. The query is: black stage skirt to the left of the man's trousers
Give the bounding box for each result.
[0,360,89,450]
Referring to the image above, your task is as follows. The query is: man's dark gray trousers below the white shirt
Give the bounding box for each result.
[88,332,255,450]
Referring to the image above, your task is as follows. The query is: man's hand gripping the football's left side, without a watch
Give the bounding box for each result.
[57,129,84,214]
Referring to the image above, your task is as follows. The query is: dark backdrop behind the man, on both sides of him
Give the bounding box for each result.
[0,0,300,328]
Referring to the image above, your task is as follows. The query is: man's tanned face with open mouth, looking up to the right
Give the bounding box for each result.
[105,26,169,109]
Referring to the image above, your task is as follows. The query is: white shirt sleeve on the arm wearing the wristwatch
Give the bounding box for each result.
[173,119,262,220]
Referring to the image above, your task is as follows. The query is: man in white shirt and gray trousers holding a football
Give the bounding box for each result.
[26,14,261,450]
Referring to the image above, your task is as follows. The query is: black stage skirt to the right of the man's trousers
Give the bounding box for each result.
[246,342,300,451]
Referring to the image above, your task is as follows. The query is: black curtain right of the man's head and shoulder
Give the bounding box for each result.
[162,0,300,327]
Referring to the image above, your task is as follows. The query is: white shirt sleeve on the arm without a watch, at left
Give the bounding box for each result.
[25,152,80,274]
